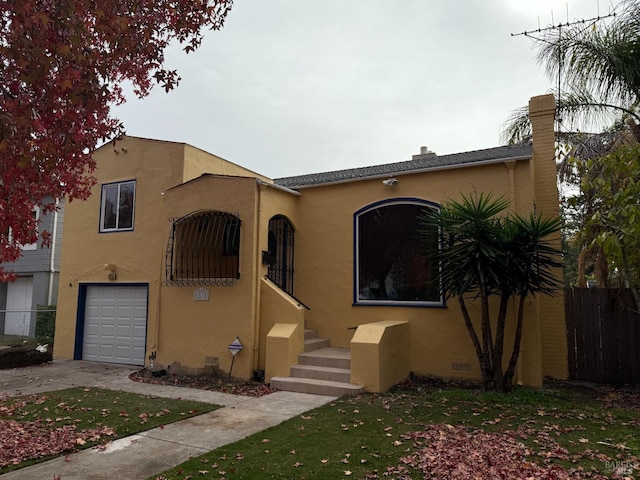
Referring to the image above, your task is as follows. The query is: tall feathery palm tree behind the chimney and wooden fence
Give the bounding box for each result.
[503,0,640,287]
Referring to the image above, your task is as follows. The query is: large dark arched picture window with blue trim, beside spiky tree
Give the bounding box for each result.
[354,199,442,306]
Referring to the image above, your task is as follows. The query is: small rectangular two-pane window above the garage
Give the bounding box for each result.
[100,180,136,232]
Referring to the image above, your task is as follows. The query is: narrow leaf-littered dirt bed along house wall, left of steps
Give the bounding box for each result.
[129,368,276,397]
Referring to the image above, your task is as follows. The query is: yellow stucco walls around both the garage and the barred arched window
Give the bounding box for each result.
[54,137,264,376]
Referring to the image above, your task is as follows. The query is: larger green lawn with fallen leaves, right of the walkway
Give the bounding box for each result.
[152,382,640,480]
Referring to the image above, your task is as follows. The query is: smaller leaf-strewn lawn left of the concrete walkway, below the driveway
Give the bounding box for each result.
[0,387,219,475]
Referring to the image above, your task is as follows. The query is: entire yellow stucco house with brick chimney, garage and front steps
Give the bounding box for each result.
[54,95,567,393]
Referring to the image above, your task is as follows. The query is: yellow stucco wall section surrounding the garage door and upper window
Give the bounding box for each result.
[54,137,184,358]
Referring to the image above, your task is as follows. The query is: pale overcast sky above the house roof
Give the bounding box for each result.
[115,0,619,178]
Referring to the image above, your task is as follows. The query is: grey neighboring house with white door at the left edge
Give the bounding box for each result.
[0,199,64,336]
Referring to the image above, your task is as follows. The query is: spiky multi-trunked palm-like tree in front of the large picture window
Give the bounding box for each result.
[421,194,561,392]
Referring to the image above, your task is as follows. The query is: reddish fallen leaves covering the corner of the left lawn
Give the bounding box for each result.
[0,420,114,468]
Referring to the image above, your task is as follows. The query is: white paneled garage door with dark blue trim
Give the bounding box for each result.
[82,285,147,365]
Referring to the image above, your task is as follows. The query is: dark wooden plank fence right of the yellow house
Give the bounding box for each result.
[565,288,640,385]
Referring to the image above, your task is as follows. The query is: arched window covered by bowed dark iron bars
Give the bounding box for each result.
[165,210,240,286]
